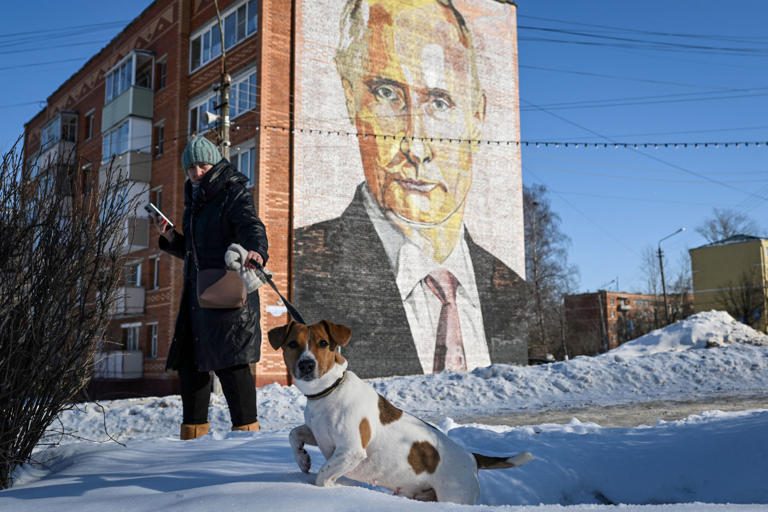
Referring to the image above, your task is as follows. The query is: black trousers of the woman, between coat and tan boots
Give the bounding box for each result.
[179,364,256,427]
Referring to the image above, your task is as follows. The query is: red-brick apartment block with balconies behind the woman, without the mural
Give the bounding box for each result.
[25,0,290,396]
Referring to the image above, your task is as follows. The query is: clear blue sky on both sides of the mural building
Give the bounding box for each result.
[0,0,768,291]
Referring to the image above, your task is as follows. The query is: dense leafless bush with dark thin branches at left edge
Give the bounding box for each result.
[0,140,132,488]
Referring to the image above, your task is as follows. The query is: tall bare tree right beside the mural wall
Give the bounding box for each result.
[523,185,578,358]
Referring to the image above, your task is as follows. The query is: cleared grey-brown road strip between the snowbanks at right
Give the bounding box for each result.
[454,394,768,427]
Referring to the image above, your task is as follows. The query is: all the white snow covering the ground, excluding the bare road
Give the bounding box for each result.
[0,312,768,512]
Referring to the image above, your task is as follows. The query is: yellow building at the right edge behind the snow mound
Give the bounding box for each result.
[689,235,768,332]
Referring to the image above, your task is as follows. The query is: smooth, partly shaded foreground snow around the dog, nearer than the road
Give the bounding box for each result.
[0,409,768,512]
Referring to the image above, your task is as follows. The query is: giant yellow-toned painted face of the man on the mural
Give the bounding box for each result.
[339,0,485,225]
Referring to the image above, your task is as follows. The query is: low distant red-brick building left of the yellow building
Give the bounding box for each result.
[565,290,692,357]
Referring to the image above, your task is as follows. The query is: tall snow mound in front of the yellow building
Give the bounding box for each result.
[603,311,768,360]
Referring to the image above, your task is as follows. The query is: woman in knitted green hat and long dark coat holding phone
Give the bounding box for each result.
[159,137,268,439]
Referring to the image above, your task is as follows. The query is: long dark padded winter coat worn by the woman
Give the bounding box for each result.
[159,160,268,371]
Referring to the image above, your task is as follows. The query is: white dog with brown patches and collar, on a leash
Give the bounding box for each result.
[269,321,532,504]
